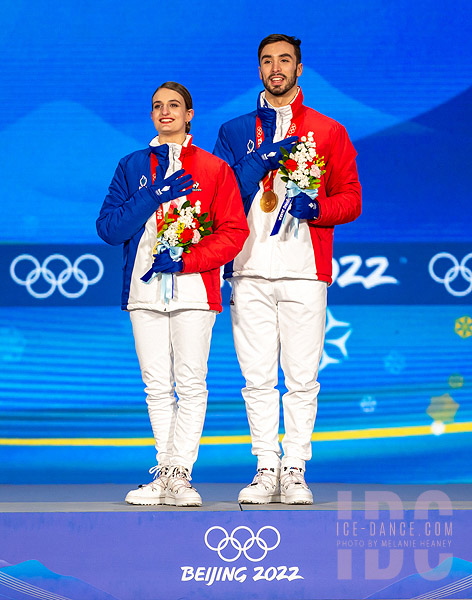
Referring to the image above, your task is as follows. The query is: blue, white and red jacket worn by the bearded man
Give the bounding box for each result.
[213,88,361,284]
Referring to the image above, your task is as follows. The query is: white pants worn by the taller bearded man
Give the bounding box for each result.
[231,277,327,468]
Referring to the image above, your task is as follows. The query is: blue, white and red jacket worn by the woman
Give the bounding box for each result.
[97,135,249,312]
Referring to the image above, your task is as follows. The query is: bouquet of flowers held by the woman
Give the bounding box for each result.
[141,200,213,304]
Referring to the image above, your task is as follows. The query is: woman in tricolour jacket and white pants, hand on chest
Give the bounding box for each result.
[97,81,249,506]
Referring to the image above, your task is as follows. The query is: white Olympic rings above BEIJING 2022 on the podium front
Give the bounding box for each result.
[205,525,280,562]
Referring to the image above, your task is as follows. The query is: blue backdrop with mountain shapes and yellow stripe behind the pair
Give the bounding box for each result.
[0,0,472,482]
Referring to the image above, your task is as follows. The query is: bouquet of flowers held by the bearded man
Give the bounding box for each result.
[271,131,326,237]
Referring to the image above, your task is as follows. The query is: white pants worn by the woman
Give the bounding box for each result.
[130,309,216,471]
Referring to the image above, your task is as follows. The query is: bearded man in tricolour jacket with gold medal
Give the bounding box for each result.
[214,34,361,504]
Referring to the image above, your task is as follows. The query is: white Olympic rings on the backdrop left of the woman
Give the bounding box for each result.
[10,254,105,299]
